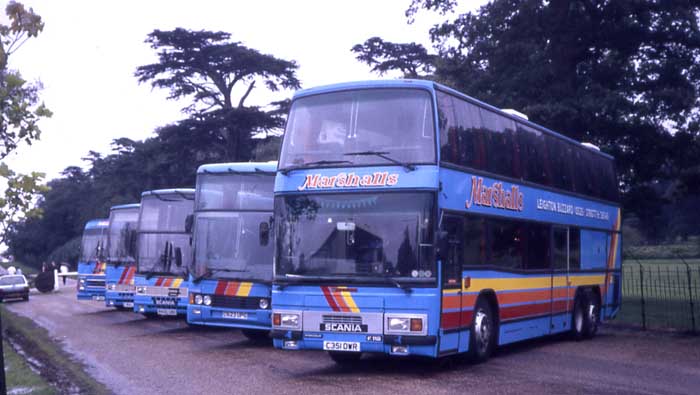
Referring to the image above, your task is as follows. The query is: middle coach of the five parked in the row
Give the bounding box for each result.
[134,188,194,317]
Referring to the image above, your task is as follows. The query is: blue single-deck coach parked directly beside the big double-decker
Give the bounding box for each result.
[187,162,277,340]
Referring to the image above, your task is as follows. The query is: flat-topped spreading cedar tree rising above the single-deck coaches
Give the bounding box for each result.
[136,28,300,161]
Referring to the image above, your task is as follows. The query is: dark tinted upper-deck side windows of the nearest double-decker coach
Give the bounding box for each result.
[437,91,619,201]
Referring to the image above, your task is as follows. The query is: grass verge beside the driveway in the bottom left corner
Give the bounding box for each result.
[0,306,111,394]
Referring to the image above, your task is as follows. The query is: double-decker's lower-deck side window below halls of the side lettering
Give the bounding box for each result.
[489,219,523,269]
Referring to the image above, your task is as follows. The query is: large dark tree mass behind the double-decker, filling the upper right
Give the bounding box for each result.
[352,0,700,241]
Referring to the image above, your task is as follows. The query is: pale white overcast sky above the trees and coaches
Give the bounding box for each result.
[2,0,485,179]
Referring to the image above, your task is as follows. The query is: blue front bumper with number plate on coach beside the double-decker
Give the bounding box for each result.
[187,304,272,331]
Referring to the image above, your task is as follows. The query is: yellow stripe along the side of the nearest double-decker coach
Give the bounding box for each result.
[464,275,605,292]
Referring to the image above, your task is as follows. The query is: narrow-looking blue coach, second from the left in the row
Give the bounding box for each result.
[105,203,140,309]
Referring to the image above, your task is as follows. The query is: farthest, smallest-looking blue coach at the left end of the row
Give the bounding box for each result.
[77,219,109,300]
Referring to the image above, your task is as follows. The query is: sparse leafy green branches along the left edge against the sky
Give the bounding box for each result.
[0,1,51,251]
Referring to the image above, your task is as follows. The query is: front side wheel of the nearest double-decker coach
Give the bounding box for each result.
[469,297,496,363]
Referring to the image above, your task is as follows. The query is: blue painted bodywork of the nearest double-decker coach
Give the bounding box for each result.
[272,80,621,357]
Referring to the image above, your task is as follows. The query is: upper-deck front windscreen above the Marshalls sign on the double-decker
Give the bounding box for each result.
[279,89,435,169]
